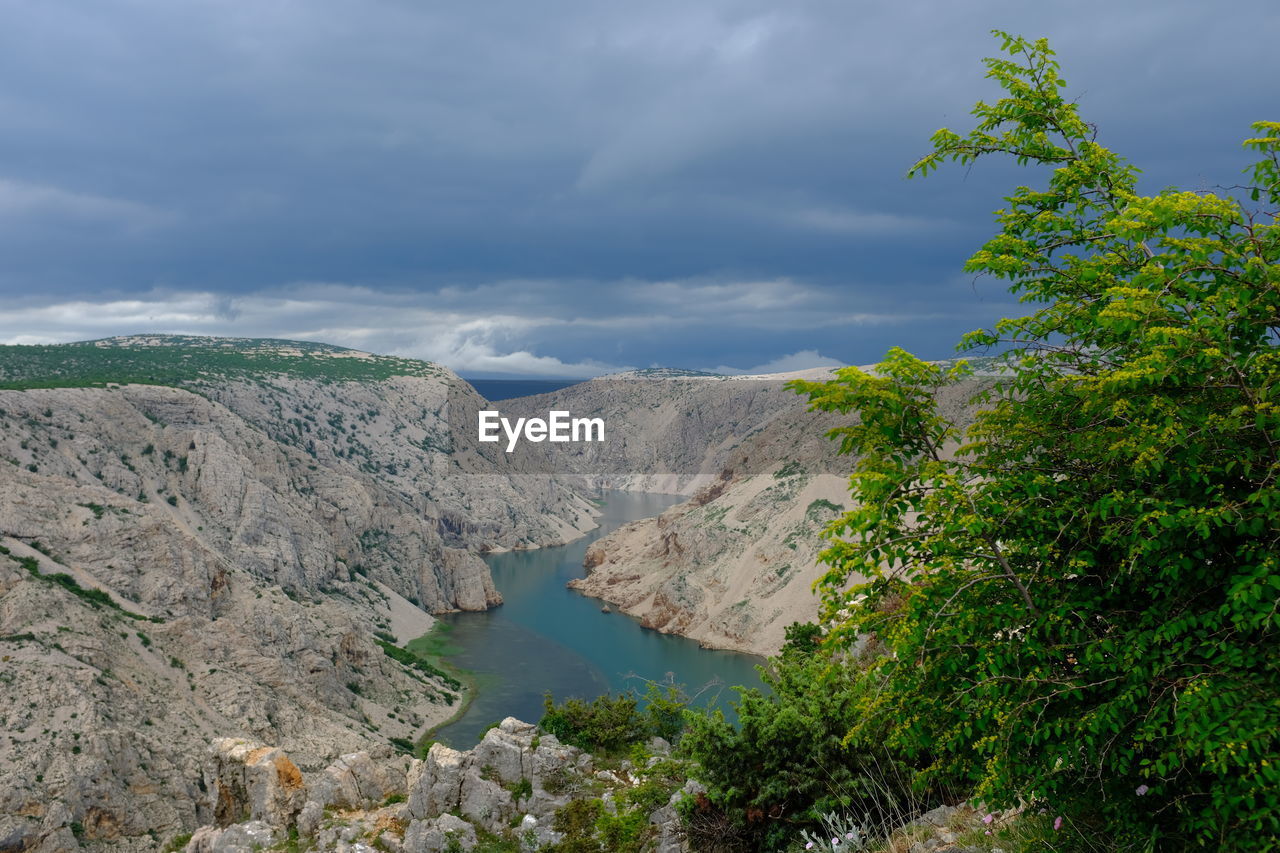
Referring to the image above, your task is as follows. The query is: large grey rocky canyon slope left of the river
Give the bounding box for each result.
[0,378,594,847]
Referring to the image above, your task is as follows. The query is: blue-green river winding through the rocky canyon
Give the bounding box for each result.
[434,492,763,749]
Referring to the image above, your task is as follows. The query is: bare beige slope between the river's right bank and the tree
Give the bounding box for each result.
[570,376,977,654]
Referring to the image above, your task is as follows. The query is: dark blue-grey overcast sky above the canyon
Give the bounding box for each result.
[0,0,1280,377]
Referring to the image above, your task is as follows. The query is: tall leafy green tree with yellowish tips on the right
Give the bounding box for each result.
[795,33,1280,850]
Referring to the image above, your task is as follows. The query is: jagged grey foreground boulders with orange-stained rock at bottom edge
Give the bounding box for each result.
[184,717,694,853]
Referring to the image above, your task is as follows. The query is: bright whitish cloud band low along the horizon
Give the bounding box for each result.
[0,282,931,378]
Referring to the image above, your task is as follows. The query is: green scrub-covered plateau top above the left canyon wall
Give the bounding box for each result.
[0,334,448,391]
